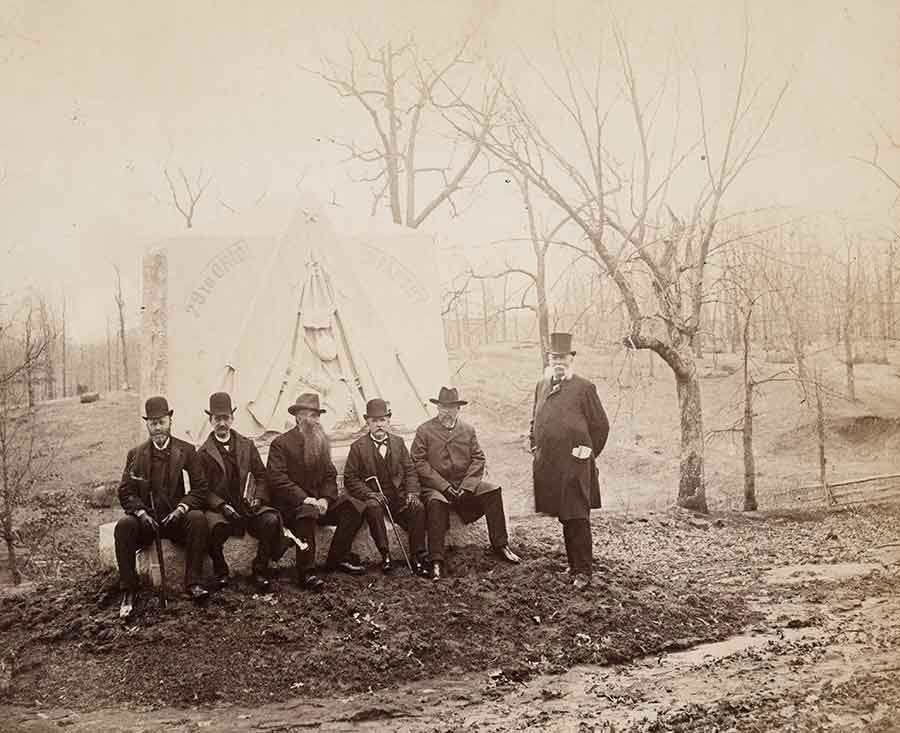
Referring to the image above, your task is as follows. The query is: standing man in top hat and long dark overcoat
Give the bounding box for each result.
[530,333,609,590]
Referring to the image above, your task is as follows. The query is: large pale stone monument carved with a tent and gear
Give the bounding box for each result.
[142,193,448,443]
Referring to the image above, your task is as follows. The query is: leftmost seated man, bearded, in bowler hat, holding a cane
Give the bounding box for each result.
[115,397,209,617]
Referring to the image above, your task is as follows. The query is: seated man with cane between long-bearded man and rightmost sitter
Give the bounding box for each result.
[344,399,426,575]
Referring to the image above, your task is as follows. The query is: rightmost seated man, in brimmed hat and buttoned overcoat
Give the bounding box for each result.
[411,387,519,580]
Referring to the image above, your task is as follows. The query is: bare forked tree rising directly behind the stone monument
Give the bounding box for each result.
[310,35,497,229]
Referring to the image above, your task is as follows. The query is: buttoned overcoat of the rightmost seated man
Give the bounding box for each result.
[410,417,500,502]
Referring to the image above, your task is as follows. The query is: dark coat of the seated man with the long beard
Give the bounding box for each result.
[266,428,365,522]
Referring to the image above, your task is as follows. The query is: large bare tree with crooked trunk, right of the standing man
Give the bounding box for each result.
[456,25,787,511]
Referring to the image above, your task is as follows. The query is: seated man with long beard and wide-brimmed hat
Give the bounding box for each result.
[266,392,365,590]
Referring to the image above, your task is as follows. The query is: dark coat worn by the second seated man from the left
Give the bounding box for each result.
[200,430,277,534]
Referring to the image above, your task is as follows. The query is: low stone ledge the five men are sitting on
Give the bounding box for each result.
[99,513,488,589]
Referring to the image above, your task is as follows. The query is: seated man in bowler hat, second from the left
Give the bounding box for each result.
[200,392,282,593]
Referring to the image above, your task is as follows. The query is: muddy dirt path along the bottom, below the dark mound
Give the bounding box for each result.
[8,546,900,732]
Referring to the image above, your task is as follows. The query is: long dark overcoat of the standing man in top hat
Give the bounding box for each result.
[531,375,609,521]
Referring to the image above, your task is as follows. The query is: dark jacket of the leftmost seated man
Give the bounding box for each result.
[118,437,208,520]
